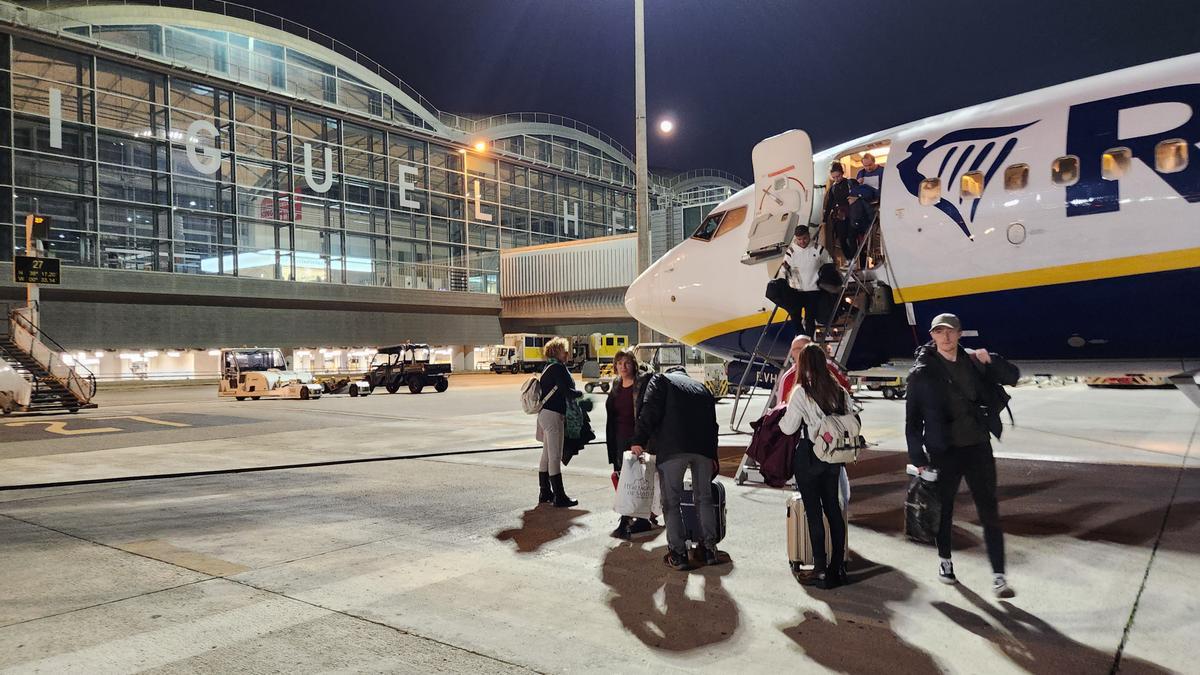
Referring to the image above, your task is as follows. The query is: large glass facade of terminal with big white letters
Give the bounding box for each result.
[0,25,634,293]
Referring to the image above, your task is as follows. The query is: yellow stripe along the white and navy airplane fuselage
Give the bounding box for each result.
[682,243,1200,345]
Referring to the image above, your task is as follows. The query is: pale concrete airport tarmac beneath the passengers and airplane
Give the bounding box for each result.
[0,375,1200,673]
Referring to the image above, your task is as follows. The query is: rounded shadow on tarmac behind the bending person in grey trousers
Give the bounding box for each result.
[600,542,740,652]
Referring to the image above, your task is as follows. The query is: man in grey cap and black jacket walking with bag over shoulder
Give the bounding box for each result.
[905,313,1020,598]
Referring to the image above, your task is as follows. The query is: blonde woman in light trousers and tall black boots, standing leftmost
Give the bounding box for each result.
[538,338,583,508]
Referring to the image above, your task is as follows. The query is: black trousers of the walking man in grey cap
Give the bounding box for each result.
[931,442,1004,574]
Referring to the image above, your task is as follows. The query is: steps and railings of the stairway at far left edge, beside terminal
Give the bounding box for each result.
[0,303,96,414]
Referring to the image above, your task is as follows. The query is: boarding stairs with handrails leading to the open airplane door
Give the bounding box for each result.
[730,209,892,485]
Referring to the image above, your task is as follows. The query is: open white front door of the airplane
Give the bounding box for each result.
[742,129,812,264]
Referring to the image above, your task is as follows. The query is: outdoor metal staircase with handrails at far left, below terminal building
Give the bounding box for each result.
[0,302,96,414]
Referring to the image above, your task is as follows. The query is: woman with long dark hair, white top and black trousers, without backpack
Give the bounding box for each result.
[779,345,853,589]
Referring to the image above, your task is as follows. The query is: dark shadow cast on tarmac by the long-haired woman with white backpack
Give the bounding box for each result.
[782,557,941,674]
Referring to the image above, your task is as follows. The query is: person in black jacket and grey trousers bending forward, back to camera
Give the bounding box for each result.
[629,366,721,571]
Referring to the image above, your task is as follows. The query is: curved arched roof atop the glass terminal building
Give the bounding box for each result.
[16,0,696,185]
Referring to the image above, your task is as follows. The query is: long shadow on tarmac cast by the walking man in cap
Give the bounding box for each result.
[934,584,1171,675]
